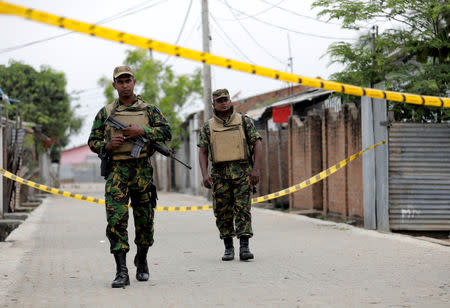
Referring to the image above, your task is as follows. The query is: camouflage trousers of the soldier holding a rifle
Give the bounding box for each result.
[105,158,156,253]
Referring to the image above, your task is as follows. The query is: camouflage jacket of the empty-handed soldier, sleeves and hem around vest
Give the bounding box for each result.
[197,116,262,180]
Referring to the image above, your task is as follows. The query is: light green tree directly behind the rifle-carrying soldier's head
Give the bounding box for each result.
[99,49,203,147]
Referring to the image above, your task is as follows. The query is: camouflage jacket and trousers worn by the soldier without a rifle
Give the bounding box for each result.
[197,112,262,239]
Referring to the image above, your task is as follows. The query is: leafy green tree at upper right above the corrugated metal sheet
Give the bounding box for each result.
[313,0,450,122]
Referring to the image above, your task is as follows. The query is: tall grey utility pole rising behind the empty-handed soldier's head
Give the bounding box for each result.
[202,0,212,122]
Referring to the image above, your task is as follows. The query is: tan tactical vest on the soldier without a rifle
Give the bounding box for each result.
[208,112,249,163]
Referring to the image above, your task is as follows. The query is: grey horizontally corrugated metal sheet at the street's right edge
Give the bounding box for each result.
[389,123,450,231]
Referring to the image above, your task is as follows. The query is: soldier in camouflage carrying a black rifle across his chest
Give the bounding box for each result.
[88,66,172,288]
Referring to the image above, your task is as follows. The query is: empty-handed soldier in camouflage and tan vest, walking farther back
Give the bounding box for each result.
[198,89,262,261]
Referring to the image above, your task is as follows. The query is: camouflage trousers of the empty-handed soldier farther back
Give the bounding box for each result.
[212,176,253,239]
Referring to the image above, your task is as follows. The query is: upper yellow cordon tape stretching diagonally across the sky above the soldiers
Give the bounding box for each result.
[0,1,450,108]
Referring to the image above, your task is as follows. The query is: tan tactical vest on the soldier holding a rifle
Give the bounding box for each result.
[105,96,149,160]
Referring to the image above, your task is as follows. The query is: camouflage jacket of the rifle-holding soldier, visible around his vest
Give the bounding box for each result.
[88,95,172,156]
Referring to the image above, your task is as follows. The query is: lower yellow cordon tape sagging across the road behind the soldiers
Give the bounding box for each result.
[0,140,386,212]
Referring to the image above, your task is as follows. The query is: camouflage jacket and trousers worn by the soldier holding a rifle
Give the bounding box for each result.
[88,97,172,253]
